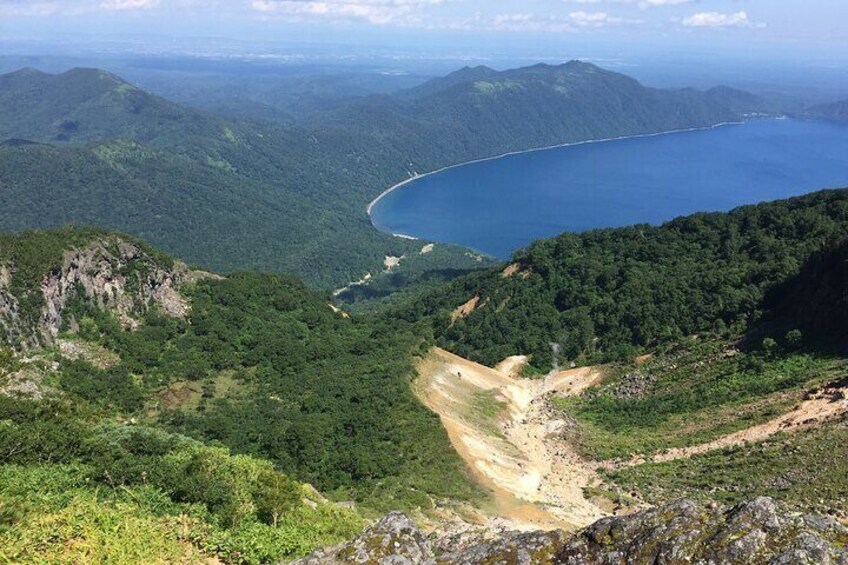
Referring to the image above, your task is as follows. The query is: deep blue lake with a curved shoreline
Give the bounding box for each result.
[371,120,848,258]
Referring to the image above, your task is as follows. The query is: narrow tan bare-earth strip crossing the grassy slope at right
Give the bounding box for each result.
[640,379,848,466]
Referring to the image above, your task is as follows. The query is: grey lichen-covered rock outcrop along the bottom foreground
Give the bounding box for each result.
[295,498,848,565]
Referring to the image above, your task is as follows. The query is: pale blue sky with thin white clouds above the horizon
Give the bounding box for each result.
[0,0,848,59]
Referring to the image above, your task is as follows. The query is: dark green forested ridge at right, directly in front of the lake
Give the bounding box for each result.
[400,190,848,370]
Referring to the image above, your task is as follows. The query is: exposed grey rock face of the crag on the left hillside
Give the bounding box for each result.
[0,236,211,348]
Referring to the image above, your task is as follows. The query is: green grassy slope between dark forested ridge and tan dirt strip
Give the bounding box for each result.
[555,334,846,459]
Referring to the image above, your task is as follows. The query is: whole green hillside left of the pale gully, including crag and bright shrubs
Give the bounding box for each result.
[0,228,479,563]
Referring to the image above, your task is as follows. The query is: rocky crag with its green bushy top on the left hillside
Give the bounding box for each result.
[0,229,212,348]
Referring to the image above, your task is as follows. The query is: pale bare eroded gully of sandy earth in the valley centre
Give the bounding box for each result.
[415,349,605,529]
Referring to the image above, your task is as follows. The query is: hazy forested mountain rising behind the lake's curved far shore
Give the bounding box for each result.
[313,61,764,191]
